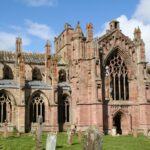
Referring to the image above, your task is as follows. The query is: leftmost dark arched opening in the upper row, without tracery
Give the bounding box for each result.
[3,65,14,80]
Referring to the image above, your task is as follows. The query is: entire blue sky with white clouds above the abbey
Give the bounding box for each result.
[0,0,150,62]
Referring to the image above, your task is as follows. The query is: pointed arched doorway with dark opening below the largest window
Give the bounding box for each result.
[113,111,128,135]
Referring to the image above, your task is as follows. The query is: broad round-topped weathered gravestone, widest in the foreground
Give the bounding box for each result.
[83,127,102,150]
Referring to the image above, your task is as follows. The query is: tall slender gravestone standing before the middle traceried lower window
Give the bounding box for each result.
[36,116,43,150]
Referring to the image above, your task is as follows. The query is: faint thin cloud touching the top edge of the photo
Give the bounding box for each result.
[20,0,56,7]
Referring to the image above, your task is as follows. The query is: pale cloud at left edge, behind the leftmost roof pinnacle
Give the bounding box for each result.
[0,31,30,50]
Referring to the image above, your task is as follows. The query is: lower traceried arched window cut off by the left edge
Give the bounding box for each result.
[0,90,12,123]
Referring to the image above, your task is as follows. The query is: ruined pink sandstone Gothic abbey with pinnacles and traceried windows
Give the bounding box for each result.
[0,20,150,135]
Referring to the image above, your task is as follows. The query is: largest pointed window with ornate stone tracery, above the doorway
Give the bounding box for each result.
[105,51,129,100]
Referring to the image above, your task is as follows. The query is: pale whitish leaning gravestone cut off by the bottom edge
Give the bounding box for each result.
[46,132,57,150]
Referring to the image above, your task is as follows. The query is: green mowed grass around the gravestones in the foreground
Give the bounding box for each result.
[0,133,150,150]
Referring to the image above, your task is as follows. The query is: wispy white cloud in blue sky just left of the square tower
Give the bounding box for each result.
[26,20,55,41]
